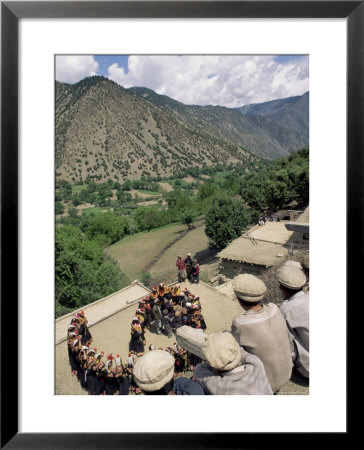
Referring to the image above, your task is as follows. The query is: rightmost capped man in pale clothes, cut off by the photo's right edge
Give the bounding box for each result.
[277,266,310,378]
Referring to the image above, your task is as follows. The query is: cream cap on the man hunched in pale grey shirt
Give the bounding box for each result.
[202,331,242,370]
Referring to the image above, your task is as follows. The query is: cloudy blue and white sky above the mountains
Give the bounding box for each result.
[55,55,309,108]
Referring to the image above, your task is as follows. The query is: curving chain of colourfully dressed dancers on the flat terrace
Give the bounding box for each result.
[67,283,206,395]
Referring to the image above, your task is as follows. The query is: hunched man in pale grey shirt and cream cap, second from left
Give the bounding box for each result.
[194,331,273,395]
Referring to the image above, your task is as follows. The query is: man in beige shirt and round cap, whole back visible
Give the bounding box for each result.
[231,273,293,393]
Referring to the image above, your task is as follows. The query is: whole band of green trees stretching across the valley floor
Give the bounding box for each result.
[56,148,309,315]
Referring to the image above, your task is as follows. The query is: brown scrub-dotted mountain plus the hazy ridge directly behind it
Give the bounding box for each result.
[55,76,308,181]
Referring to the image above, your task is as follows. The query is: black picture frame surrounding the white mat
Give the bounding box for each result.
[0,0,356,450]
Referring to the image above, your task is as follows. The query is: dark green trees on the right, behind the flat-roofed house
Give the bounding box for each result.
[203,148,309,249]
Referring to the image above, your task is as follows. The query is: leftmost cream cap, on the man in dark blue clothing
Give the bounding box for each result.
[133,350,174,392]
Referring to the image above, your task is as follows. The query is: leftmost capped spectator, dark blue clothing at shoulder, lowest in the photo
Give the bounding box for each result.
[133,350,204,395]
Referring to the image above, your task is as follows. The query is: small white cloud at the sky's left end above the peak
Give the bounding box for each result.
[56,55,99,83]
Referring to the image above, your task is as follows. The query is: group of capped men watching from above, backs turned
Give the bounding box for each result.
[129,255,309,395]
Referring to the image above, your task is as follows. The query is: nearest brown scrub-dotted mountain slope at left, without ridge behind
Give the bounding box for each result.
[56,76,258,181]
